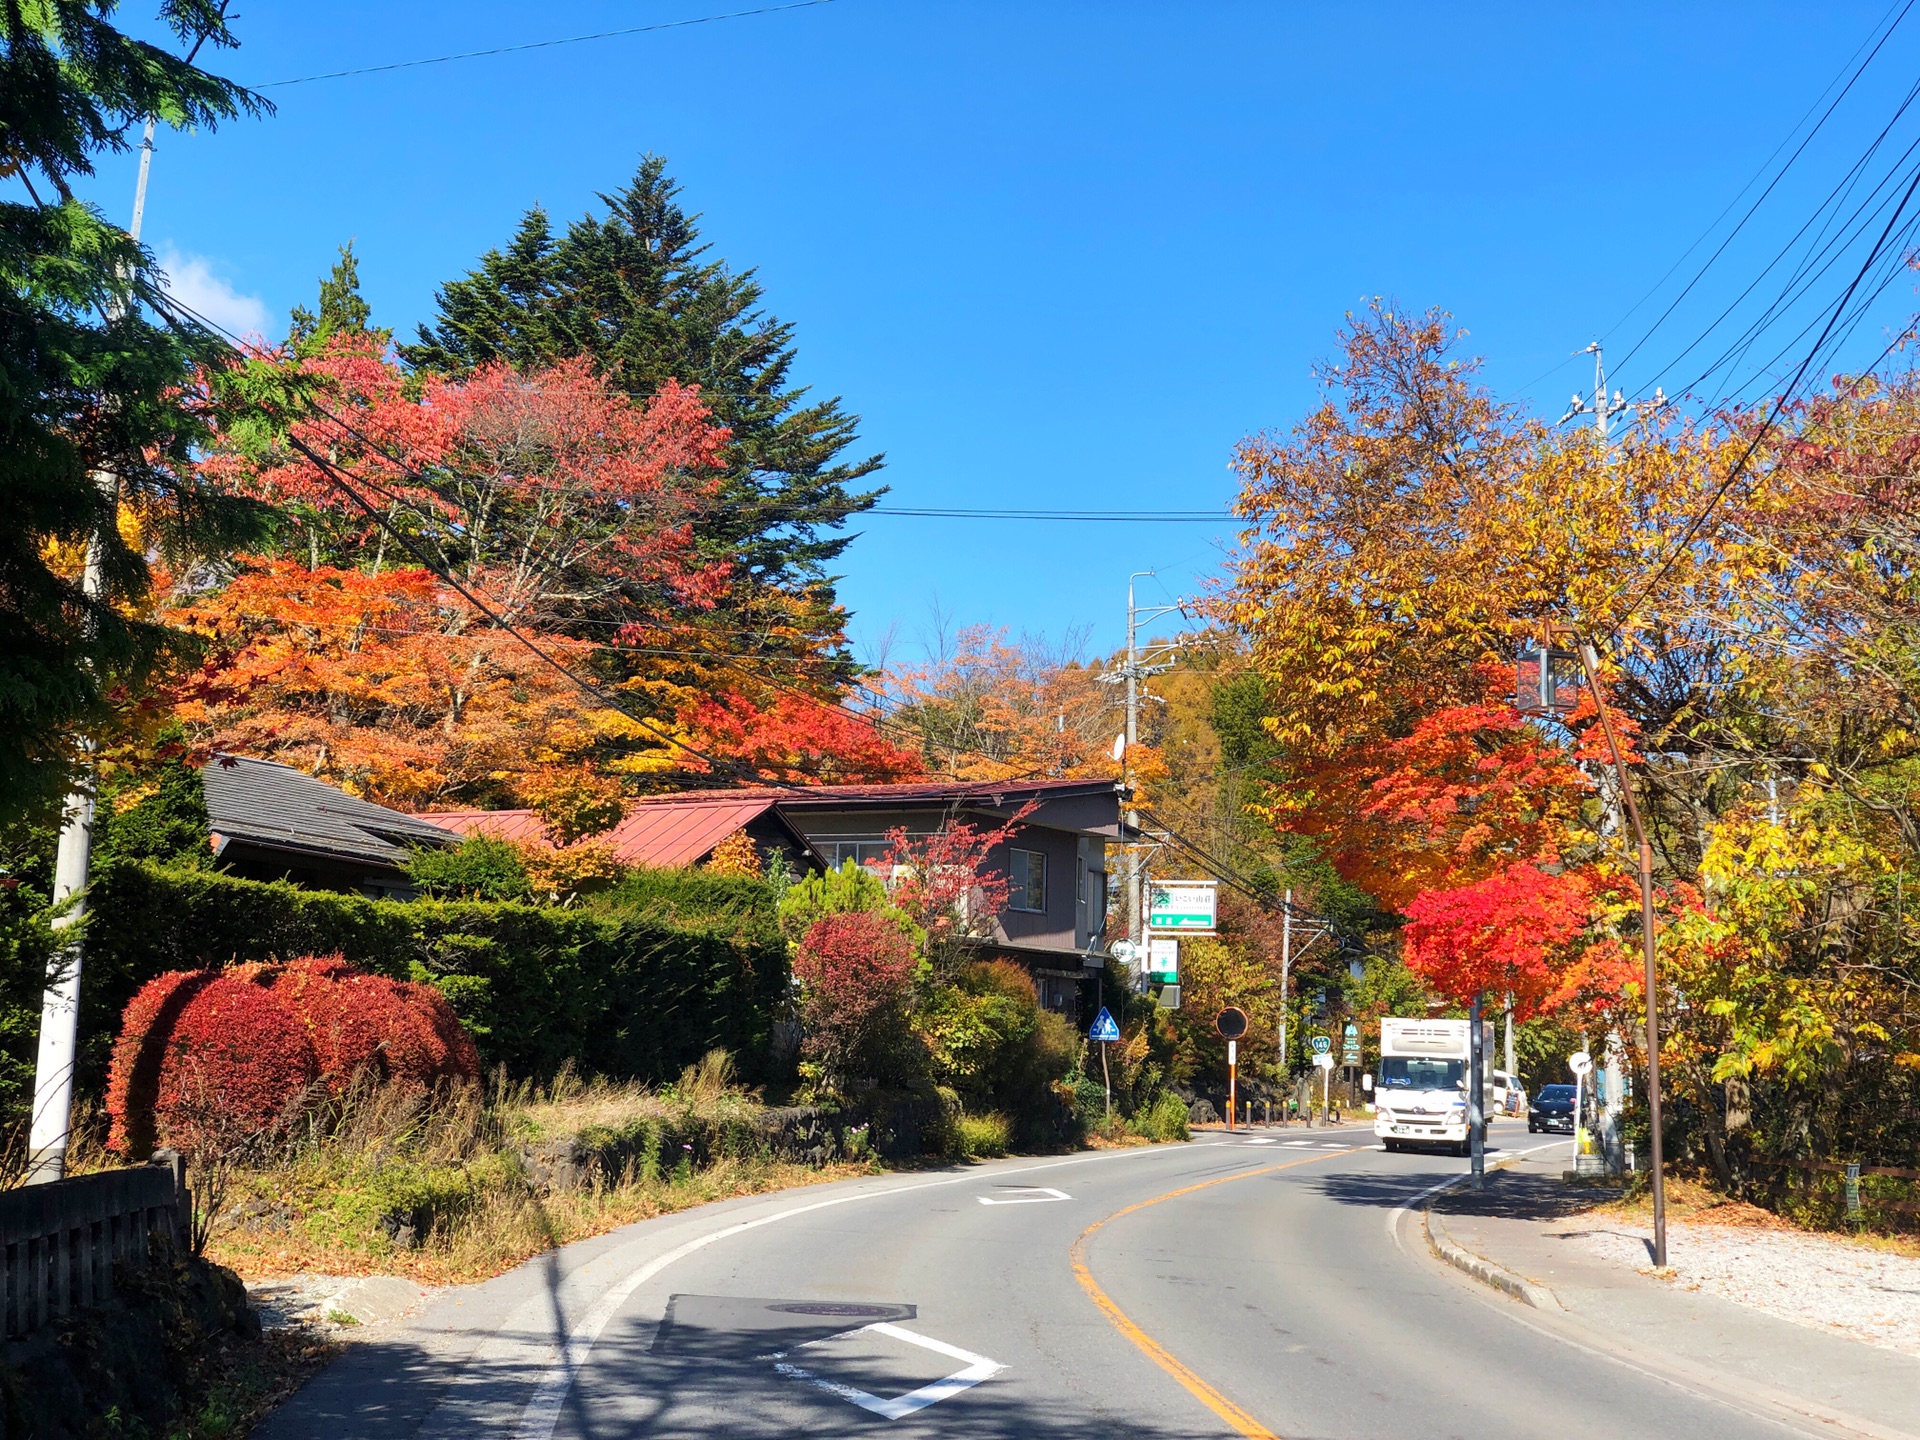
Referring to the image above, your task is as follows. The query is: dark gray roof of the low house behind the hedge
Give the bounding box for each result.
[200,755,461,868]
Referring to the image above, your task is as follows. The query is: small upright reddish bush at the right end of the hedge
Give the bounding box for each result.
[793,910,914,1089]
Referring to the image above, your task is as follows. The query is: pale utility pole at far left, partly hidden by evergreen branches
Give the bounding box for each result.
[27,121,159,1185]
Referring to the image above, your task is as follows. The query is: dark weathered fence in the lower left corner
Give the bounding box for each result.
[0,1150,192,1338]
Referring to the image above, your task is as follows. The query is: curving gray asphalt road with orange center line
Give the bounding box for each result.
[259,1125,1835,1440]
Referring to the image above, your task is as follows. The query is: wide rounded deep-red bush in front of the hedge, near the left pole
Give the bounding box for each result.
[108,956,480,1158]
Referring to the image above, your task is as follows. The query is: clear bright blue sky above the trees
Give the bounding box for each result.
[88,0,1920,659]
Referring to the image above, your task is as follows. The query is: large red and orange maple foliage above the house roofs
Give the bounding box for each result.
[179,334,914,814]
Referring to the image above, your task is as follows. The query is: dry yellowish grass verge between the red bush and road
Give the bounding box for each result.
[194,1054,872,1284]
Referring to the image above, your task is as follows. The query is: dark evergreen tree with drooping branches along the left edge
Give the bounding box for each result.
[0,0,267,820]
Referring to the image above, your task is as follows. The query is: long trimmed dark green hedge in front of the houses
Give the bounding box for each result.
[54,860,787,1113]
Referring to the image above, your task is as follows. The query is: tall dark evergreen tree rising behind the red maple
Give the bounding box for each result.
[401,156,883,607]
